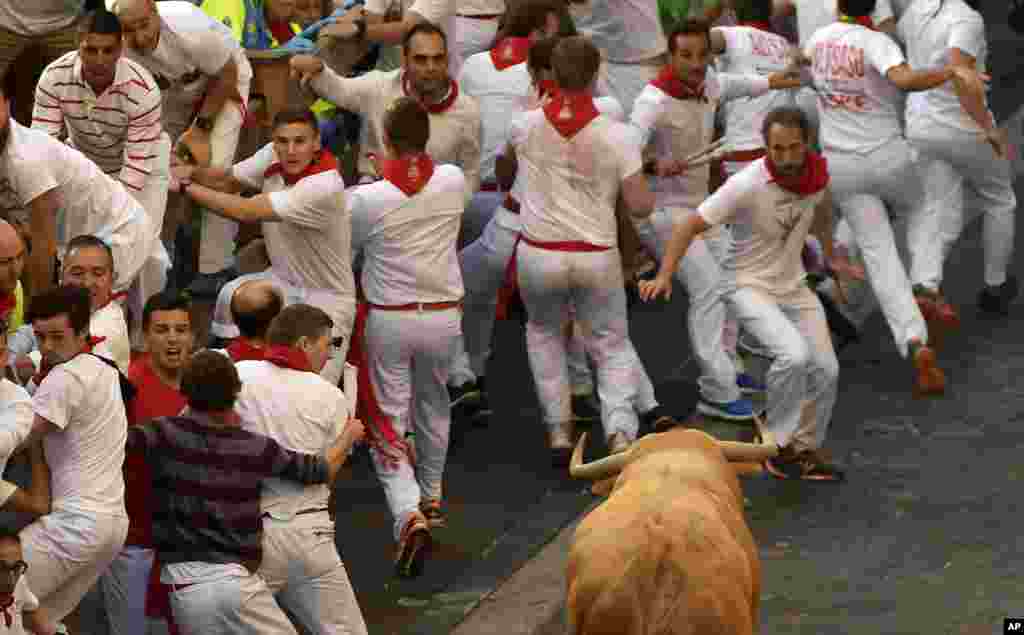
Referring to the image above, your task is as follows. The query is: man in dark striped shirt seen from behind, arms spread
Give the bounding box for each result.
[127,350,362,635]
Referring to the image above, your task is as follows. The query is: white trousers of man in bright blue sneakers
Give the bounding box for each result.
[636,208,741,404]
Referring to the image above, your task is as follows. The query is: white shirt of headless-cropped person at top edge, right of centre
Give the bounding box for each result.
[577,0,669,64]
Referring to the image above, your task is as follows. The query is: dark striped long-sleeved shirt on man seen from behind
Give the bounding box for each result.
[127,411,328,572]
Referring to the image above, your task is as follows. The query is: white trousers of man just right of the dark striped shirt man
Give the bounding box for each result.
[259,511,367,635]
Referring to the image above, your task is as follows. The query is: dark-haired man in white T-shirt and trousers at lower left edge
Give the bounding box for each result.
[0,286,128,633]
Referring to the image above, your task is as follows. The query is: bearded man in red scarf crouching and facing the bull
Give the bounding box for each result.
[640,108,861,480]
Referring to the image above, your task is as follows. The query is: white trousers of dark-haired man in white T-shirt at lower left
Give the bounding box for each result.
[20,511,128,622]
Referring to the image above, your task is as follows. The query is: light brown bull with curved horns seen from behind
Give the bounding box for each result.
[566,428,777,635]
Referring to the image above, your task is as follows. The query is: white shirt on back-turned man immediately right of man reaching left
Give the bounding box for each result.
[348,165,466,304]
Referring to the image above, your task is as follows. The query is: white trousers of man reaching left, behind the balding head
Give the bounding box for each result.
[210,268,355,385]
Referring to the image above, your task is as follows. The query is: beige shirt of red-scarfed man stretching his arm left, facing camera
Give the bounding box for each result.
[309,67,481,202]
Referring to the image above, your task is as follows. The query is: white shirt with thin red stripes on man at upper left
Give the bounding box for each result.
[32,51,163,192]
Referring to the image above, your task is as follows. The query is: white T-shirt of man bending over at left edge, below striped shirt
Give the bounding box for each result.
[0,119,149,251]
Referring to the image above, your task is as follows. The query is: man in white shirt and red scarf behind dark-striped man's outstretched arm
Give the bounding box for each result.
[236,304,367,635]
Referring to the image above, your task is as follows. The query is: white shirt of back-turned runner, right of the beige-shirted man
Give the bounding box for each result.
[459,51,534,183]
